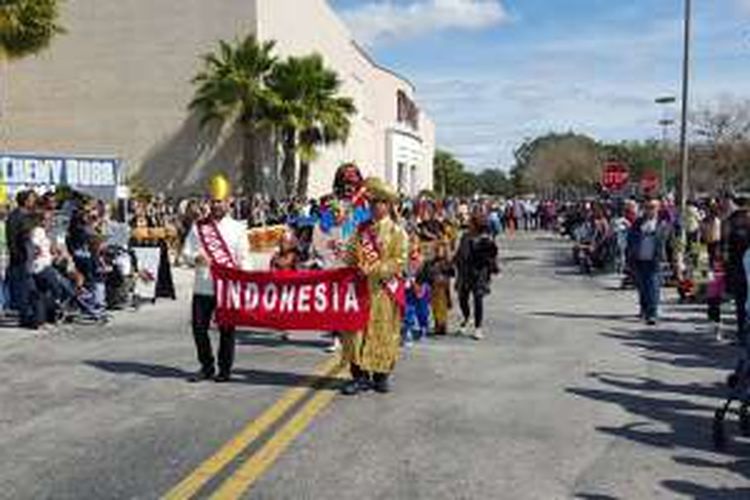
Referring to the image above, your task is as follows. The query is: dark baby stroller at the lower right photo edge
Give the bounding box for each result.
[713,343,750,450]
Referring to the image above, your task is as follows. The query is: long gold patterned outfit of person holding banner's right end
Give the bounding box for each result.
[342,218,408,376]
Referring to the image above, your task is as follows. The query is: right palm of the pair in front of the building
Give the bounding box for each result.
[267,54,356,197]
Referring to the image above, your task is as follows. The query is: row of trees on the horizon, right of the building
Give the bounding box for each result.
[434,98,750,196]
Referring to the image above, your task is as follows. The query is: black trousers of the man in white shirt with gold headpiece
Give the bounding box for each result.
[193,295,235,376]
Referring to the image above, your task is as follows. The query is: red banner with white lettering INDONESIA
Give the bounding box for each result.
[212,267,370,331]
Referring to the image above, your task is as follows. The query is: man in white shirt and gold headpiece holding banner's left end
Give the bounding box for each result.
[182,176,252,383]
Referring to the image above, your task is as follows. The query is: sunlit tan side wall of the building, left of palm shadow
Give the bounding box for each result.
[5,0,255,189]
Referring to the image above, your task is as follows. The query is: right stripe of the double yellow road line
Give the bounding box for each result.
[211,372,344,500]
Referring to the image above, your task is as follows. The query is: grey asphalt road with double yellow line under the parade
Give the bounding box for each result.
[0,235,750,500]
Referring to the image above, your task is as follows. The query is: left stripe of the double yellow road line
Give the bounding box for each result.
[163,356,341,500]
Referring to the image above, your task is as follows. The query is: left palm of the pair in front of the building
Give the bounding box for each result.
[190,35,276,193]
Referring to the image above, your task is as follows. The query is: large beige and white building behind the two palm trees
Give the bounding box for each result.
[2,0,435,199]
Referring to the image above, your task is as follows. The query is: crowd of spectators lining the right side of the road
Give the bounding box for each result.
[560,192,750,344]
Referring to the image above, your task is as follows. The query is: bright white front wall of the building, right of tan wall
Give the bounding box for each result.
[257,0,434,196]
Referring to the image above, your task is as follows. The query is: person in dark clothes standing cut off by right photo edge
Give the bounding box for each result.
[723,198,750,345]
